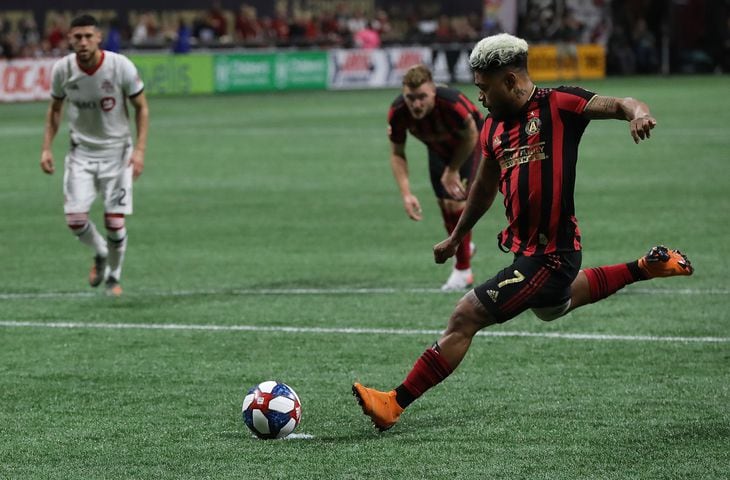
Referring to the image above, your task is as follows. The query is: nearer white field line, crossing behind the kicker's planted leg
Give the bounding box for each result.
[0,320,730,343]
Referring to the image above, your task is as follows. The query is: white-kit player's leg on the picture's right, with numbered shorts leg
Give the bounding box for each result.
[99,147,132,296]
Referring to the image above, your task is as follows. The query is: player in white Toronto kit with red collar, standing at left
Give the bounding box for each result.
[41,15,149,296]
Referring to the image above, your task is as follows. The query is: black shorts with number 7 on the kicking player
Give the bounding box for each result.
[474,251,582,323]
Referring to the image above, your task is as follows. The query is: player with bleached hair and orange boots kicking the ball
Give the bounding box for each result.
[353,34,693,431]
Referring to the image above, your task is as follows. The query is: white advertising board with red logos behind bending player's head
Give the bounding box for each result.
[329,47,431,89]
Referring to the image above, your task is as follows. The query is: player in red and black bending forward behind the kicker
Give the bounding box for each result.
[388,65,483,291]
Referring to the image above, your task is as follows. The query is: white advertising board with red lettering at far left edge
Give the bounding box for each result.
[0,58,58,102]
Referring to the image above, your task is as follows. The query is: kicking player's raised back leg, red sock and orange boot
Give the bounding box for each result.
[570,245,694,310]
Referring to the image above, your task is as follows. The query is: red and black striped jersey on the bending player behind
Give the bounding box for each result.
[388,87,484,159]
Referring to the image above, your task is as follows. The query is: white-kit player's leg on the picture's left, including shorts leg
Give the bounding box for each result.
[63,152,108,287]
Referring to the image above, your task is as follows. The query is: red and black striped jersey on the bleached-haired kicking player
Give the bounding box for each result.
[480,87,595,255]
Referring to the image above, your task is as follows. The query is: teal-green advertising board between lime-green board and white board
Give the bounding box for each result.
[215,52,328,92]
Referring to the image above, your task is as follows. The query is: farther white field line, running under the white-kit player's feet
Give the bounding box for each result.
[0,287,730,300]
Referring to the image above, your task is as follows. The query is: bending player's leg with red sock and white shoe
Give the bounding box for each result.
[428,150,475,291]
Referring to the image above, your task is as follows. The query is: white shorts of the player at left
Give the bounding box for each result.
[63,145,132,215]
